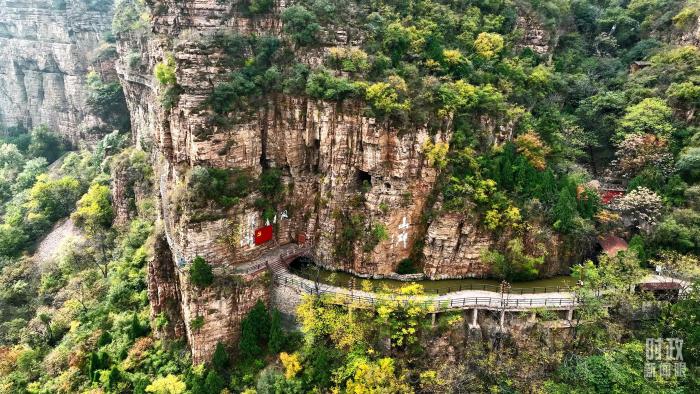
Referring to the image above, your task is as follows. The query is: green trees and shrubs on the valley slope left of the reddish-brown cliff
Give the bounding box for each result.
[0,130,164,393]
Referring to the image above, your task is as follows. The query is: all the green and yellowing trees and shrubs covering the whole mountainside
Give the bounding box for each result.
[0,0,700,394]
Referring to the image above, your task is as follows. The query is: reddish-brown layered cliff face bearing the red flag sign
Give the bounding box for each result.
[117,0,568,362]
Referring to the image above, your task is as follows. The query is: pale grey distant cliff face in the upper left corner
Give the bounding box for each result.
[0,0,112,143]
